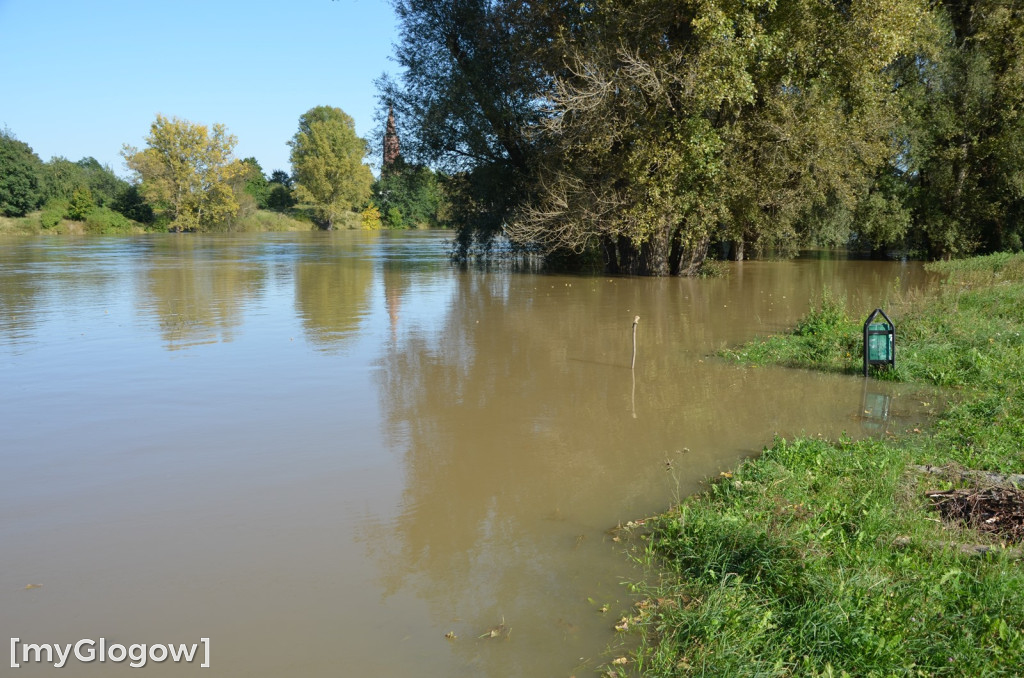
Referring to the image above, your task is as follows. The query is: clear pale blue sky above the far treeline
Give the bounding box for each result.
[0,0,397,176]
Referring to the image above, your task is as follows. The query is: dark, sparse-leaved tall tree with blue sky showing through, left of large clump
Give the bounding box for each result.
[379,0,590,255]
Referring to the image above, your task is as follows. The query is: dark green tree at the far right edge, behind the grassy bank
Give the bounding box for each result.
[893,0,1024,257]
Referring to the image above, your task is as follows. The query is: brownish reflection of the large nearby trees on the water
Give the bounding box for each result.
[359,261,937,676]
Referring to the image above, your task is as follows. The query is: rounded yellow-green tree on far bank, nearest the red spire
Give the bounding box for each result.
[288,105,374,229]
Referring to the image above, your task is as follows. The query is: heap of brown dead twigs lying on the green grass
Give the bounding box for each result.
[928,488,1024,544]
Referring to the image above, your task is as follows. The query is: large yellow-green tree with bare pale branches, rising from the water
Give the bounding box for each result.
[509,0,925,276]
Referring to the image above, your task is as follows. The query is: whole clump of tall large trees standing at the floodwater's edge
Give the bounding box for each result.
[379,0,1024,276]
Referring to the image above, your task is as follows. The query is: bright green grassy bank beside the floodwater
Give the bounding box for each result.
[612,255,1024,676]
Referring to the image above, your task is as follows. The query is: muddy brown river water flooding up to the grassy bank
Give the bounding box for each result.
[0,234,927,678]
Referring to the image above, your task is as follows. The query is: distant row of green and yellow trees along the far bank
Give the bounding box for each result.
[0,107,442,232]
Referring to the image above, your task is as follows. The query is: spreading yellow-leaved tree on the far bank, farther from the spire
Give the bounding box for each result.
[121,114,245,231]
